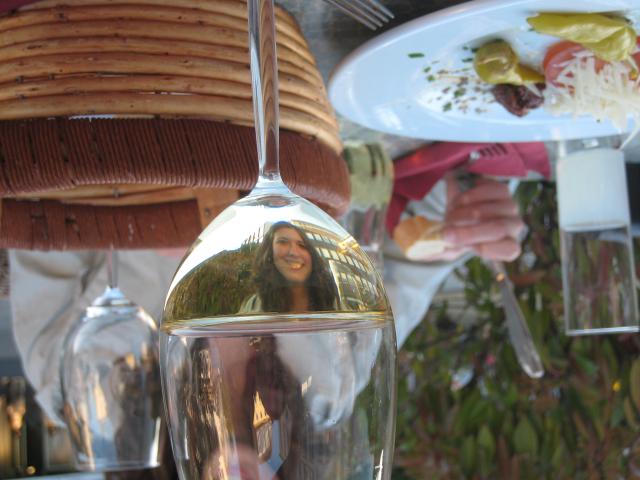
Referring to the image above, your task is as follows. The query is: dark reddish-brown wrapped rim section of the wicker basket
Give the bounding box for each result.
[0,119,350,250]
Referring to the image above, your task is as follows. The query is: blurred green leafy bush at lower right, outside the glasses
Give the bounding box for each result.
[394,182,640,480]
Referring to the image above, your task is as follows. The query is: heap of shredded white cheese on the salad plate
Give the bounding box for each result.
[544,50,640,131]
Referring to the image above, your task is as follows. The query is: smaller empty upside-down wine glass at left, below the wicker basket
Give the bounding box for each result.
[60,251,163,471]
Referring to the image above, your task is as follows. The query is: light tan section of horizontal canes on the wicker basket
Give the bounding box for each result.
[0,0,342,153]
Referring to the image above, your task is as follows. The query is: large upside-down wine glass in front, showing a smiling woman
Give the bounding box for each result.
[160,0,396,480]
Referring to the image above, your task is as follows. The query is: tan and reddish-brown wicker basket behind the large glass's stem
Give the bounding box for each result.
[0,0,349,250]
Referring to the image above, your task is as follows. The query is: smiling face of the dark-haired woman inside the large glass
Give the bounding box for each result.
[273,227,313,284]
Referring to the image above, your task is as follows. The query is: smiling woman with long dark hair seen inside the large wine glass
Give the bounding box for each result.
[241,222,338,312]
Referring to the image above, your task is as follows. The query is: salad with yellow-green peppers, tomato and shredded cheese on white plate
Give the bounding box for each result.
[474,13,640,130]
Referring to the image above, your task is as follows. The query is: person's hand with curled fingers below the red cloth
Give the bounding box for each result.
[433,175,525,261]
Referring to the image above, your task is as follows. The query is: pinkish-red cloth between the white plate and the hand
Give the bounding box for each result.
[386,142,551,234]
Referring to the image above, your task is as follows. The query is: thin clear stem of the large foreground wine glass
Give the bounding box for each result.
[247,0,281,186]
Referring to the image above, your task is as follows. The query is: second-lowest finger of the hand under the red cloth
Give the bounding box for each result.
[442,217,524,246]
